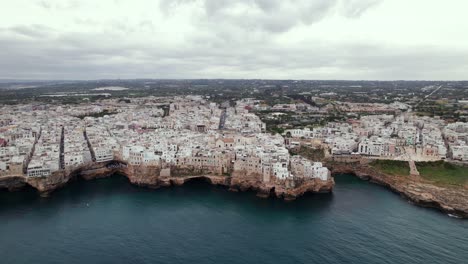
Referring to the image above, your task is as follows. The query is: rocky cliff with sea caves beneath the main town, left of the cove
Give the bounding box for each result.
[0,161,335,200]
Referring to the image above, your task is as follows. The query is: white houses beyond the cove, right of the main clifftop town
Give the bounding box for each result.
[285,114,468,161]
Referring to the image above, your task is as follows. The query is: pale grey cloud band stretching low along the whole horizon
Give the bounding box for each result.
[0,26,468,79]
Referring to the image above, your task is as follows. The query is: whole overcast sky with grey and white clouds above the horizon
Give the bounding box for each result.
[0,0,468,80]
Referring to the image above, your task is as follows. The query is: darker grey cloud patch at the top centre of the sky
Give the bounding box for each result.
[160,0,381,33]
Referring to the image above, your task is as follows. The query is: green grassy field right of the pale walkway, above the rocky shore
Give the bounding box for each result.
[416,161,468,186]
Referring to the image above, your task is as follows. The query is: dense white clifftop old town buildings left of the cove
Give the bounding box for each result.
[0,96,330,182]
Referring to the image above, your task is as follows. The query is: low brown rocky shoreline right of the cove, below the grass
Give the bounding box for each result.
[328,163,468,219]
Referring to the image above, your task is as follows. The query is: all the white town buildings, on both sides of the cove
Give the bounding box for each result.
[0,96,468,182]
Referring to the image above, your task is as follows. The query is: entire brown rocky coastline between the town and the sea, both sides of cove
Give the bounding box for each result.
[0,161,468,219]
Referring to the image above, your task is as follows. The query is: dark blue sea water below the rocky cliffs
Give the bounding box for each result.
[0,175,468,264]
